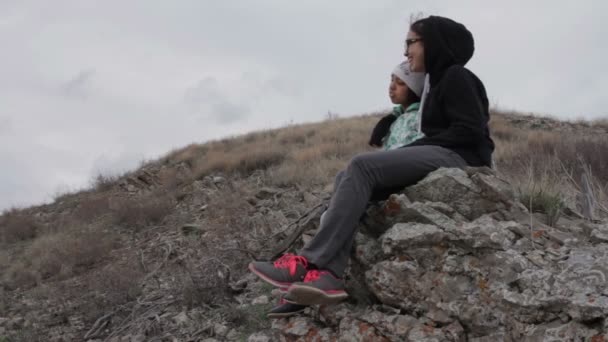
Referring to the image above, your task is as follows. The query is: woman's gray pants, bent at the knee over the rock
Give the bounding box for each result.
[299,146,467,277]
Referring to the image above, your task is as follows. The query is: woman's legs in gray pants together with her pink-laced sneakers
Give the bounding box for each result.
[249,146,466,292]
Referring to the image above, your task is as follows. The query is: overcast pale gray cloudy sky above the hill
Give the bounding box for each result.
[0,0,608,209]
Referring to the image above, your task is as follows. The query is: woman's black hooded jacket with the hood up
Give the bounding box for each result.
[408,16,494,166]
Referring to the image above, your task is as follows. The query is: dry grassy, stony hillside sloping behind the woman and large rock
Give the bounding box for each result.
[0,111,608,341]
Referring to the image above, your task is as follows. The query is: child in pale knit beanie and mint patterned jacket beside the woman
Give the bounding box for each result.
[268,62,424,318]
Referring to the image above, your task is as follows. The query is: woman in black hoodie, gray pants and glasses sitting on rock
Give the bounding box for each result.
[249,16,494,305]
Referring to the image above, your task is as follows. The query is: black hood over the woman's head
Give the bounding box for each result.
[414,16,475,84]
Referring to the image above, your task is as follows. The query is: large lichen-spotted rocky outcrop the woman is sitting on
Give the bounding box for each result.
[262,168,608,342]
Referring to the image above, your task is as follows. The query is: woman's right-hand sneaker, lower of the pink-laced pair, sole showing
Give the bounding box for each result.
[285,270,348,305]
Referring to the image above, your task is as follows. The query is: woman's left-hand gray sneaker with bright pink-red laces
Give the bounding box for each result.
[249,254,308,288]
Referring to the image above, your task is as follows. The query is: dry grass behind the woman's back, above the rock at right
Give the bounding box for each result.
[491,113,608,224]
